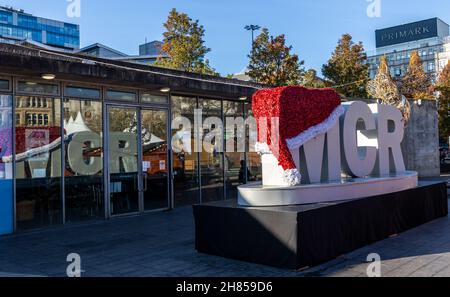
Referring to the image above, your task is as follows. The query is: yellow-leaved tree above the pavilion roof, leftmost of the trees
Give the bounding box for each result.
[155,8,217,75]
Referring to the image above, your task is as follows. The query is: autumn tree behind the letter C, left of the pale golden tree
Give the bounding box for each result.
[322,34,369,98]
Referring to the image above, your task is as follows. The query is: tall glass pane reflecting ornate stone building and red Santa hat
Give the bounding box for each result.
[15,96,62,229]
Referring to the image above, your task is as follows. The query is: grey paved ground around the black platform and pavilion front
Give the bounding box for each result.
[0,178,450,277]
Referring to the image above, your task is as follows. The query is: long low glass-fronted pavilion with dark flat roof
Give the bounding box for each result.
[0,44,261,234]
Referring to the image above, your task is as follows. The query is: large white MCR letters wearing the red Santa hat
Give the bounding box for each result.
[262,101,406,186]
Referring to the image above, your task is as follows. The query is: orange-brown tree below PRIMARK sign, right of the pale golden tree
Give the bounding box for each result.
[399,51,433,99]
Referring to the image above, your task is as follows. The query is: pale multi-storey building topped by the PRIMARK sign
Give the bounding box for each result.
[367,18,450,79]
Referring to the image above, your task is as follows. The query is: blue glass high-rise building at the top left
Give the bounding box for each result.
[0,6,80,49]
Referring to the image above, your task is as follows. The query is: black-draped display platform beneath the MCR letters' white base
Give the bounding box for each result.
[194,182,448,269]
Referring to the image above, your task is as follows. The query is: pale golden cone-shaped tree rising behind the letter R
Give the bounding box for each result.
[367,56,411,123]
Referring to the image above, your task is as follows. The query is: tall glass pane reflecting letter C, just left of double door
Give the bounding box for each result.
[64,99,104,222]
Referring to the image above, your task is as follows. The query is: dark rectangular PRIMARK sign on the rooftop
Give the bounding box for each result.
[375,18,438,48]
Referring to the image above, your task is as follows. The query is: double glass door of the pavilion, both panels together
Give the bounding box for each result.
[107,106,170,216]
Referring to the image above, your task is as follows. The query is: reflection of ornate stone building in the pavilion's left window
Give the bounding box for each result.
[15,96,55,127]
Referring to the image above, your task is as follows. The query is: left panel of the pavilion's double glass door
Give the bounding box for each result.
[107,106,141,216]
